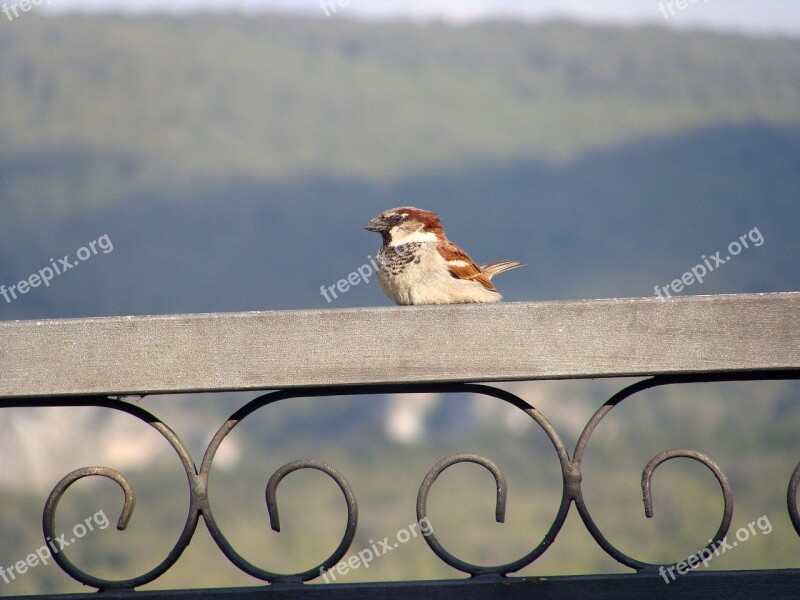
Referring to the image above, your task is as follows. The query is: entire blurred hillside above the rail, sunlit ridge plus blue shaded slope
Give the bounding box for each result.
[0,15,800,319]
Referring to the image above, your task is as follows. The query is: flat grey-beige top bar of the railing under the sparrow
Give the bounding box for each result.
[0,292,800,398]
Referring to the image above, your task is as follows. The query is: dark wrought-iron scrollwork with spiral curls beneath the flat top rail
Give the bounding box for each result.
[0,371,800,590]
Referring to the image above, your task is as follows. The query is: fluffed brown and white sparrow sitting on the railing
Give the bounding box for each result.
[364,206,524,305]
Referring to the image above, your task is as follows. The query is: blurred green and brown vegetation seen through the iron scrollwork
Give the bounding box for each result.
[0,380,800,594]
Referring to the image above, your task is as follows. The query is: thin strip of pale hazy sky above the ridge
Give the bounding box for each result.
[41,0,800,36]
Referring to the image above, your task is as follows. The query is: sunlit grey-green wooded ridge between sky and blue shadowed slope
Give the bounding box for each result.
[0,16,800,185]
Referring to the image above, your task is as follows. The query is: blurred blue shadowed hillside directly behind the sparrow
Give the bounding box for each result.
[0,125,800,319]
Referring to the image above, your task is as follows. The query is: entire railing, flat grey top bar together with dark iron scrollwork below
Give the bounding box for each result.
[0,293,800,597]
